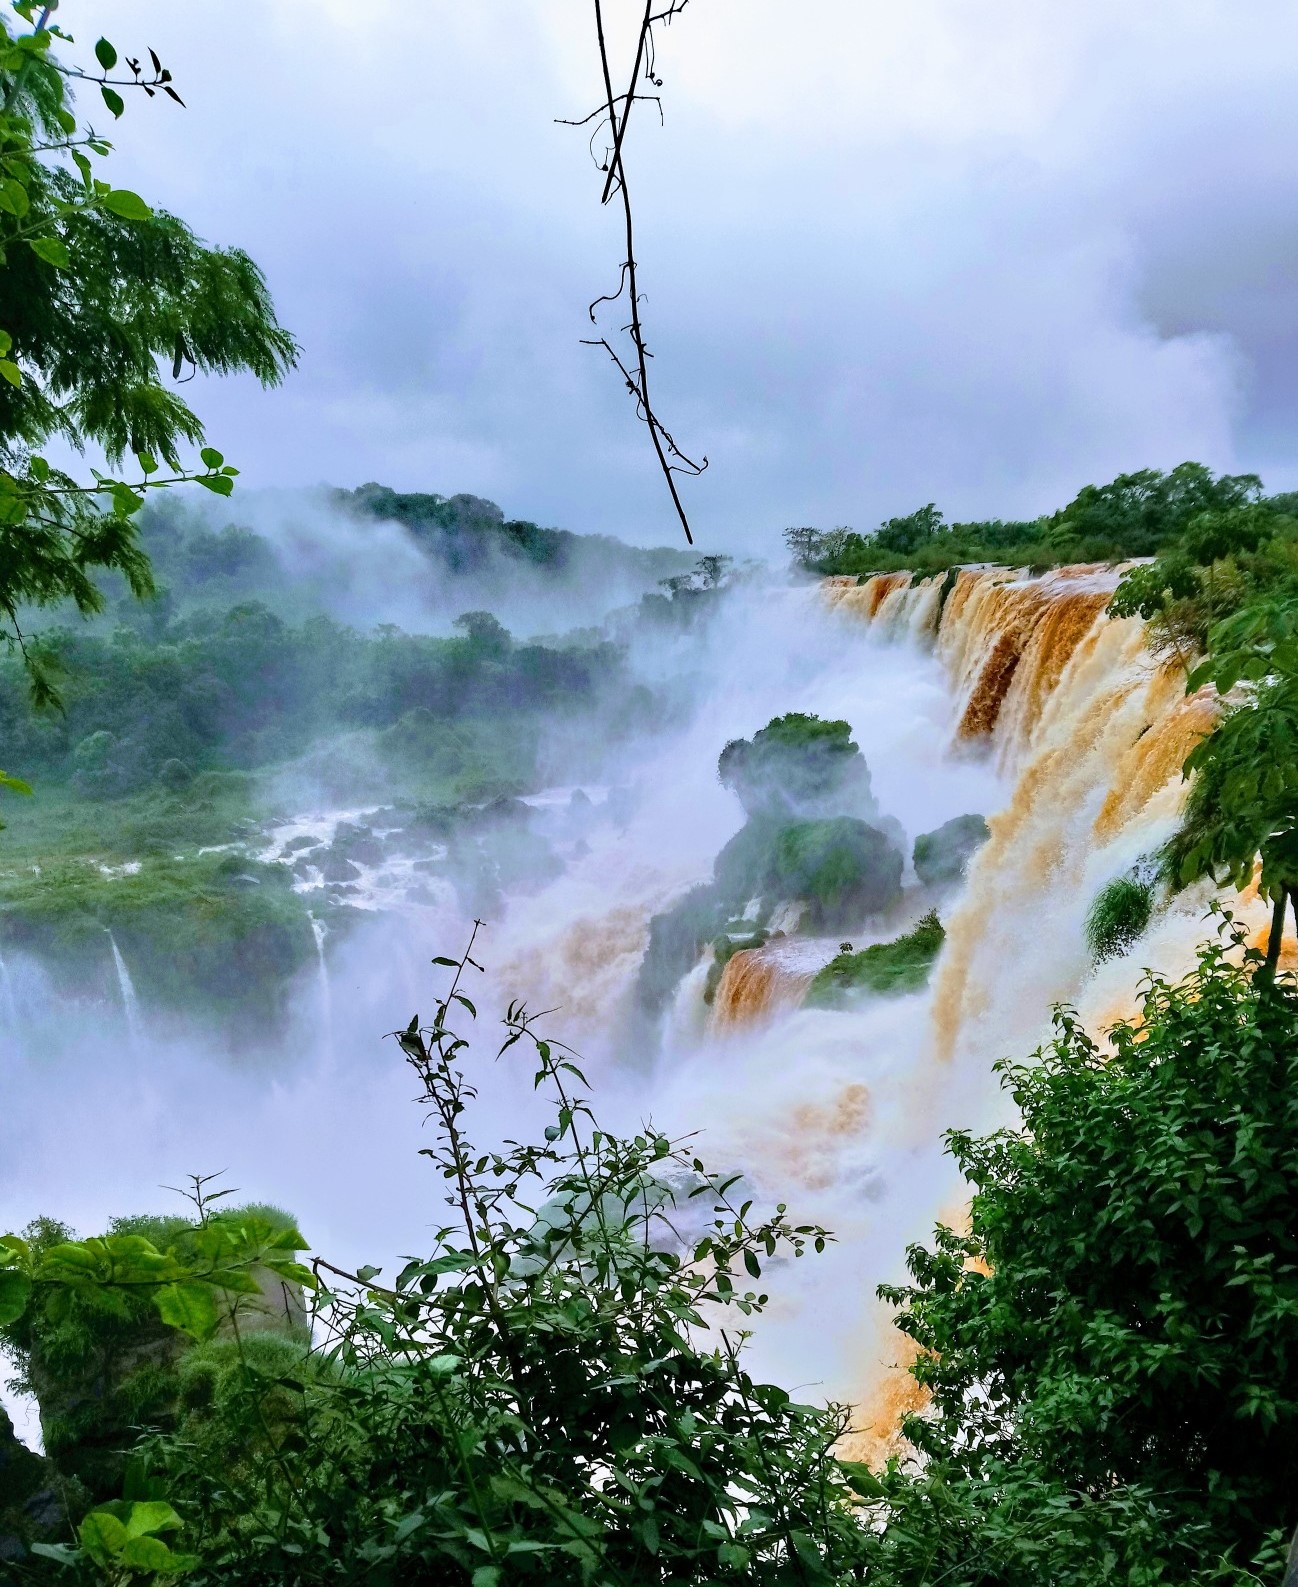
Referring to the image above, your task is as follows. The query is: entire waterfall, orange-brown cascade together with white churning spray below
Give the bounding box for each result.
[0,570,1265,1454]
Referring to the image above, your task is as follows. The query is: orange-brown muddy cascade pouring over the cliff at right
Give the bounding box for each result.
[824,567,1298,1455]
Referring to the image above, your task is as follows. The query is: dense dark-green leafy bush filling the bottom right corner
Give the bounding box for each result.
[870,917,1298,1587]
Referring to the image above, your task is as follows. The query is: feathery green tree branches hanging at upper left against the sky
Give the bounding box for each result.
[0,0,297,703]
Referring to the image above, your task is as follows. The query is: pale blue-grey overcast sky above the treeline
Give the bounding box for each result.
[75,0,1298,551]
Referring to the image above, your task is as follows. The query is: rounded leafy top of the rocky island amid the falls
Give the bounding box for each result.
[717,711,873,817]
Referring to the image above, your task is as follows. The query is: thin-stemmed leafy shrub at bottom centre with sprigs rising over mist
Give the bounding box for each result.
[7,943,858,1587]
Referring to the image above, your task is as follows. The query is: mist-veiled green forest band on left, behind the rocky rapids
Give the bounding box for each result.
[0,601,649,797]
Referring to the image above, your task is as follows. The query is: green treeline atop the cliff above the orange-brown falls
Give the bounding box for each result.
[784,463,1298,576]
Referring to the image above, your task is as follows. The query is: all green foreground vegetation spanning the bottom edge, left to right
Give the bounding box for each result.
[0,916,1298,1587]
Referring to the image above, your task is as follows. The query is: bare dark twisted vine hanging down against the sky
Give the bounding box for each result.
[562,0,708,544]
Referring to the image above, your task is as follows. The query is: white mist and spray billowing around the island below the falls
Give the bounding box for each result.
[0,571,1003,1440]
